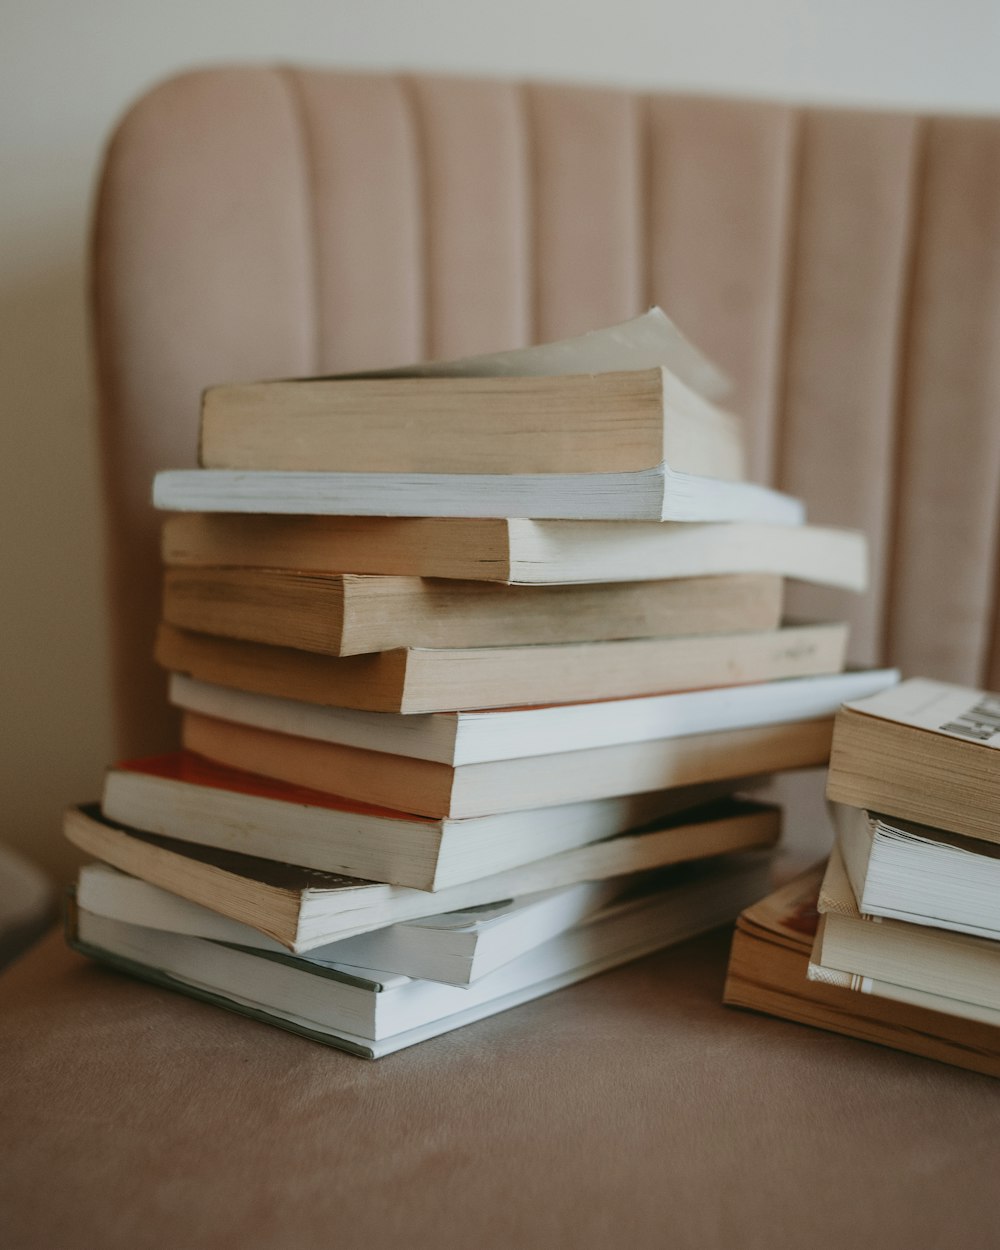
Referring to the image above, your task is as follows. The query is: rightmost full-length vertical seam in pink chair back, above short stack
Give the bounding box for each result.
[873,118,929,661]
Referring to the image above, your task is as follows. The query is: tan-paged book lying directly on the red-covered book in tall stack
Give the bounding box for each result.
[181,713,834,825]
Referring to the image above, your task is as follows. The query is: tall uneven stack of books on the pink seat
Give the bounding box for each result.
[66,310,895,1056]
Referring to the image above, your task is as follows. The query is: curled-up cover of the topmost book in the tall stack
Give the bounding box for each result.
[341,305,733,400]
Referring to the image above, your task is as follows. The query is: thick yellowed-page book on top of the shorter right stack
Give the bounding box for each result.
[826,678,1000,843]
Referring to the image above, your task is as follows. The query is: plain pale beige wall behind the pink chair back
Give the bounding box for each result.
[0,0,1000,873]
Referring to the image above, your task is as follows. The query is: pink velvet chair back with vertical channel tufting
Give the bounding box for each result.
[94,68,1000,751]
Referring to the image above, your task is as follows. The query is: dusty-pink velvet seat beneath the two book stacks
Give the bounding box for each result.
[0,931,1000,1250]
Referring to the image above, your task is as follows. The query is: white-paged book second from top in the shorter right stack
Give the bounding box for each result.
[830,803,1000,940]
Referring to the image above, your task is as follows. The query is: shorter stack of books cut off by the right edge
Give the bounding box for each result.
[726,679,1000,1076]
